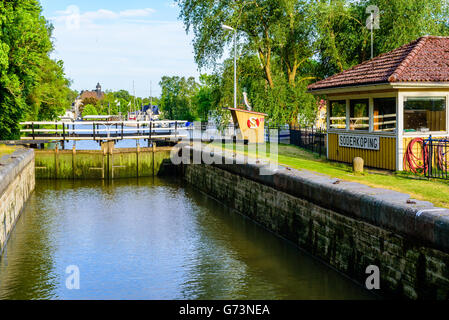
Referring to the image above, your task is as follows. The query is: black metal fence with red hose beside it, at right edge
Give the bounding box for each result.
[422,137,449,180]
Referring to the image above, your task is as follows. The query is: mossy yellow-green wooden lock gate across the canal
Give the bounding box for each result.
[36,146,171,179]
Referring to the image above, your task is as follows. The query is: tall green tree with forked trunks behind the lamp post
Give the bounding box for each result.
[178,0,315,123]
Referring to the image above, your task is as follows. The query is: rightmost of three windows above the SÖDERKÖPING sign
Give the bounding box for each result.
[373,98,396,132]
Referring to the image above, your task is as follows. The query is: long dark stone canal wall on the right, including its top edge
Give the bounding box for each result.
[182,148,449,299]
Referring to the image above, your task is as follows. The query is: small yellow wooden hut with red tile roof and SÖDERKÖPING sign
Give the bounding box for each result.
[308,36,449,170]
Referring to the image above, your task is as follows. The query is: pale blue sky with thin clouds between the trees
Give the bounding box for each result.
[40,0,199,97]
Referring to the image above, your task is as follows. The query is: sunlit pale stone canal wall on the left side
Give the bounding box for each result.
[0,149,35,255]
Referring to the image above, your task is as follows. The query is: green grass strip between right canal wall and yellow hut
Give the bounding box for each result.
[210,143,449,208]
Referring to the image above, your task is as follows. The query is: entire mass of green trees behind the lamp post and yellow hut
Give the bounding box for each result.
[177,0,449,124]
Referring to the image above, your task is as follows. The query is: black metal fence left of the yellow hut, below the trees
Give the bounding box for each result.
[290,127,326,156]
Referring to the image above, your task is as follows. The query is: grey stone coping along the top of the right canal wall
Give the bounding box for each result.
[187,146,449,252]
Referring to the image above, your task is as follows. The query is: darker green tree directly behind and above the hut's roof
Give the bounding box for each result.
[313,0,449,78]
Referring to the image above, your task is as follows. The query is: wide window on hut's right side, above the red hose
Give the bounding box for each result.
[404,97,446,132]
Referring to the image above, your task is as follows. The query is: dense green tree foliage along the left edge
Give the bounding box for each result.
[0,0,72,139]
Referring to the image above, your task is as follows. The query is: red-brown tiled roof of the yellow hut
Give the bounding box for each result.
[308,36,449,91]
